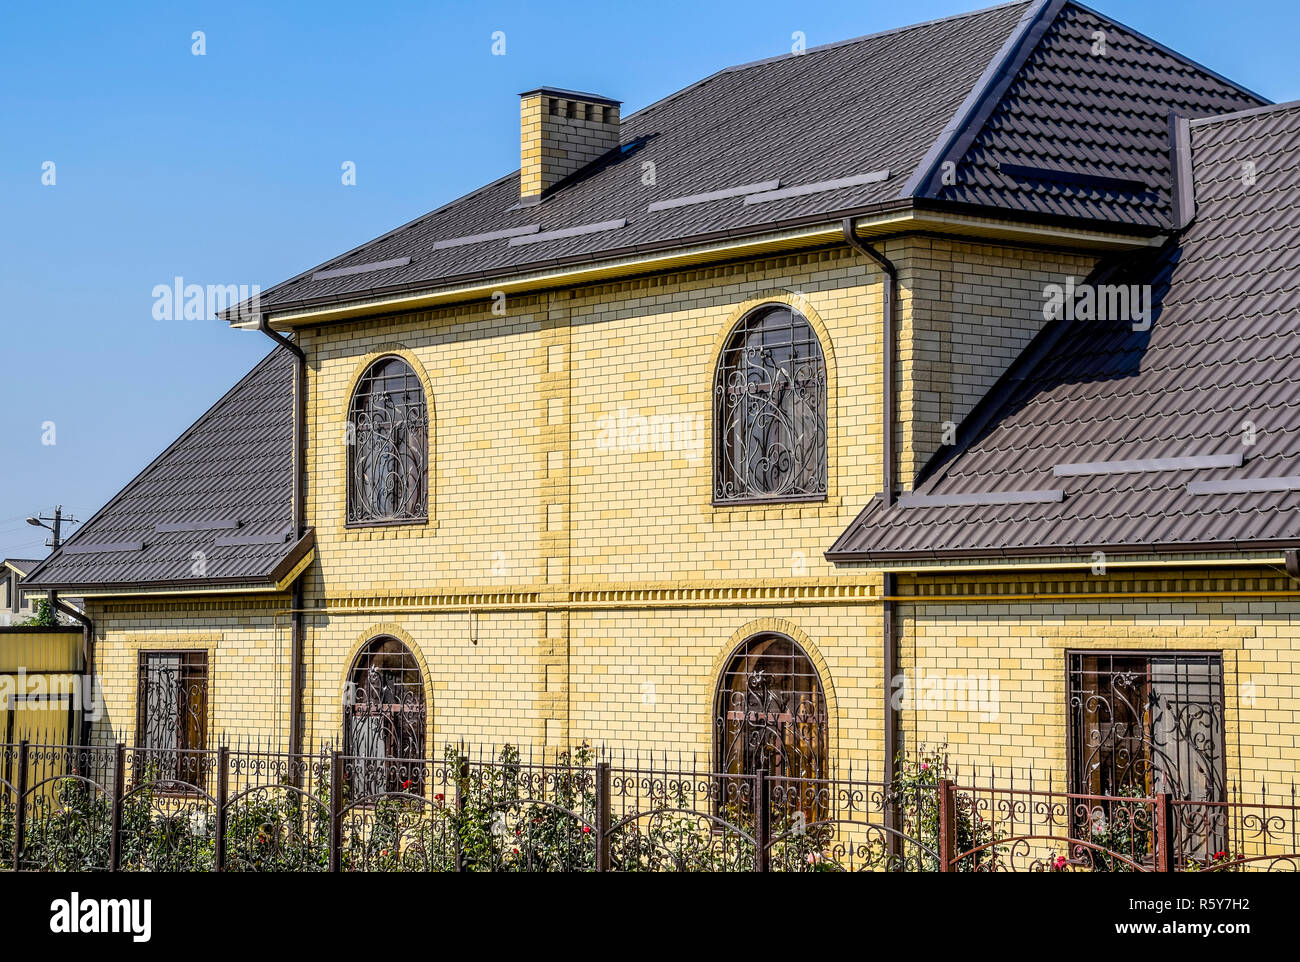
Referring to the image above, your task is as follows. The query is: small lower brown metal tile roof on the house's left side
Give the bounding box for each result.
[23,348,306,590]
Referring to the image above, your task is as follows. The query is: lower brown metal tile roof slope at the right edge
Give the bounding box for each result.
[827,101,1300,562]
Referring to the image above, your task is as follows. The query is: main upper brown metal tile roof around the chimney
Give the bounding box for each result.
[241,0,1265,317]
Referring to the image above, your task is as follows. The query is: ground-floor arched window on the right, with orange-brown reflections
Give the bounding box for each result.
[714,634,829,796]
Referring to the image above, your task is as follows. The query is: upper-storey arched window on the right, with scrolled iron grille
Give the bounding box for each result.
[714,304,827,503]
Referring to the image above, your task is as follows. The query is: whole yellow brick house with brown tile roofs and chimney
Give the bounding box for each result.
[15,1,1300,798]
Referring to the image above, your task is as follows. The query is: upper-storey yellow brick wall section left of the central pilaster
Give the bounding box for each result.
[303,298,549,594]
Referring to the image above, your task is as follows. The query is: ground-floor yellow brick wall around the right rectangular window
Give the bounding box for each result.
[900,571,1300,794]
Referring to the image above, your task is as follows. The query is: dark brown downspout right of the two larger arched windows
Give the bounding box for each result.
[842,217,901,790]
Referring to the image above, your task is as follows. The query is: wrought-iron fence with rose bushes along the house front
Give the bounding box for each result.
[0,742,1300,871]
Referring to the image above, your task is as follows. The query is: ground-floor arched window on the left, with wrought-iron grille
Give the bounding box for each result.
[343,636,426,794]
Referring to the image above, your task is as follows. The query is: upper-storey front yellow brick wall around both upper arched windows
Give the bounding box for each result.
[303,244,899,594]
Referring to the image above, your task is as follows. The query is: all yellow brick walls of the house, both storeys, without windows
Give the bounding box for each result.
[81,231,1297,806]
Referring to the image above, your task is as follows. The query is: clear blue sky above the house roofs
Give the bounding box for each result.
[0,0,1300,558]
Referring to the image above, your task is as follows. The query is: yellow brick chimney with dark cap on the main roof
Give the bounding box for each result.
[519,87,623,204]
